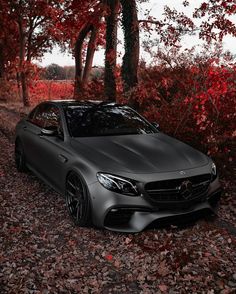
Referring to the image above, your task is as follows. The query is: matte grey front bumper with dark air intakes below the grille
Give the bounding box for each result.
[89,178,221,233]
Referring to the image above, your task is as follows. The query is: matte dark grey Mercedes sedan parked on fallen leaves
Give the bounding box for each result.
[15,100,221,232]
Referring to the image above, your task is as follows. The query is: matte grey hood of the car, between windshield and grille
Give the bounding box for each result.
[71,133,209,174]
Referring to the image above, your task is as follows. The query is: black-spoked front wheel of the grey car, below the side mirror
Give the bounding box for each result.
[65,172,91,227]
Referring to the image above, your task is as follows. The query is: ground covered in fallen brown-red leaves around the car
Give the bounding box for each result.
[0,105,236,294]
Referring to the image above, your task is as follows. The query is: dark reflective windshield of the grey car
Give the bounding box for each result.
[65,105,158,137]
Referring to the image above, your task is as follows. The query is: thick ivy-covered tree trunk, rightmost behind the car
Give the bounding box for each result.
[121,0,139,94]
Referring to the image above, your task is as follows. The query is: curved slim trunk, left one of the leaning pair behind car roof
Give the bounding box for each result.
[74,23,92,98]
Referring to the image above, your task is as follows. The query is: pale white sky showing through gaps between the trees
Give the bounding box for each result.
[37,0,236,66]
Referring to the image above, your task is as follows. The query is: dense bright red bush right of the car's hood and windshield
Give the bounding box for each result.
[127,62,236,175]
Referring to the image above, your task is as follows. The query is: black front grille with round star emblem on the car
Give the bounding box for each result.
[145,174,211,208]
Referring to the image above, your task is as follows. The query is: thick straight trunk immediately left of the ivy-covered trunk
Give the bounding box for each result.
[104,0,120,101]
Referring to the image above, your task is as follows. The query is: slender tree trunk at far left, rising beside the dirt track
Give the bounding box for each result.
[18,19,30,106]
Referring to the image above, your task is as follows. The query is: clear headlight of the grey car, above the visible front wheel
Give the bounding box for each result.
[97,173,139,196]
